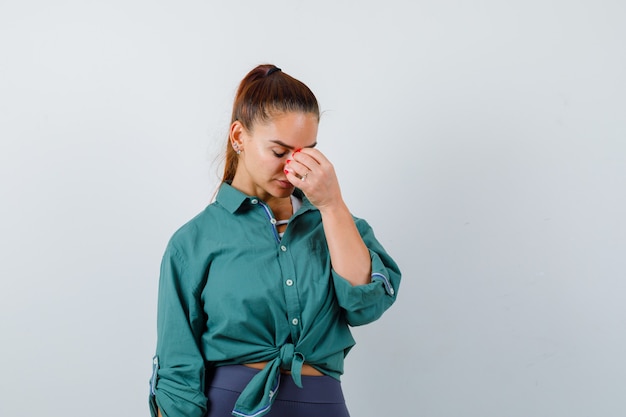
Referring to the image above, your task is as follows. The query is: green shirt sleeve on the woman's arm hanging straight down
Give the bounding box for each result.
[150,244,207,417]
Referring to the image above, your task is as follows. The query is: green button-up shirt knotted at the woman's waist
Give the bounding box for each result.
[151,183,400,417]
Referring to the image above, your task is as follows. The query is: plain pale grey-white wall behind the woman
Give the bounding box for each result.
[0,0,626,417]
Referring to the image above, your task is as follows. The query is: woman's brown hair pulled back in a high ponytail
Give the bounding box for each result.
[222,64,320,181]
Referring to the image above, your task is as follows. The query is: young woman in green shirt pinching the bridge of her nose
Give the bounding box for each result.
[150,65,400,417]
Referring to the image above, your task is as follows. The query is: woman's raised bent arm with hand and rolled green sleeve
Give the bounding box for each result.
[285,148,401,326]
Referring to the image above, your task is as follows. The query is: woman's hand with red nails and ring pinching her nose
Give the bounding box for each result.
[285,148,343,211]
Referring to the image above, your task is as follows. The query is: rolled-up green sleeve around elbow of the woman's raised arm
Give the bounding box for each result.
[332,219,401,326]
